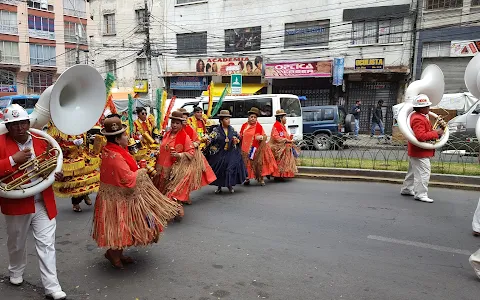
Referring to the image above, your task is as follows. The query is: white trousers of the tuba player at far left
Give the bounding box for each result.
[5,201,62,295]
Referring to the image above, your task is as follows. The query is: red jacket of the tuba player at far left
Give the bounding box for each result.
[0,134,57,219]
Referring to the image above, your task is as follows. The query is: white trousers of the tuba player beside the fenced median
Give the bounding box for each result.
[402,157,431,198]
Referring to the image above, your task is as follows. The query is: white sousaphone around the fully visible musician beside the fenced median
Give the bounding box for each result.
[397,65,450,149]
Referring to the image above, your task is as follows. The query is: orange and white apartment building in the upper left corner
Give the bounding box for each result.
[0,0,88,96]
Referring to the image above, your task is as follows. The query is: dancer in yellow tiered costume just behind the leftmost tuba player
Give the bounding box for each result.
[47,122,100,212]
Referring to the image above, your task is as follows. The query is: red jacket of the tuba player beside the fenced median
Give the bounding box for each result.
[408,112,438,158]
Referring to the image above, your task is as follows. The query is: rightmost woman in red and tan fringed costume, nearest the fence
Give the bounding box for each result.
[268,109,299,181]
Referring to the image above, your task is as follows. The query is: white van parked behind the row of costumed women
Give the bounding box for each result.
[183,94,303,140]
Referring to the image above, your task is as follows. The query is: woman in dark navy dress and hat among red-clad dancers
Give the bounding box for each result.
[207,110,247,194]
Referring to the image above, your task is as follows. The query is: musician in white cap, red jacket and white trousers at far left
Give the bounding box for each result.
[0,104,66,300]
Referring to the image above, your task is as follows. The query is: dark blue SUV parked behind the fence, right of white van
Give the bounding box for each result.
[302,105,352,150]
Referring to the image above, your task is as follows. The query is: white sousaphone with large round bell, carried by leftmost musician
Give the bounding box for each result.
[0,65,107,199]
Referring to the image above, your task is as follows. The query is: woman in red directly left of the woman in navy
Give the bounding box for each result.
[178,108,217,199]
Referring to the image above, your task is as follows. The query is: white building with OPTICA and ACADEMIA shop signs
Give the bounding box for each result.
[158,0,415,132]
